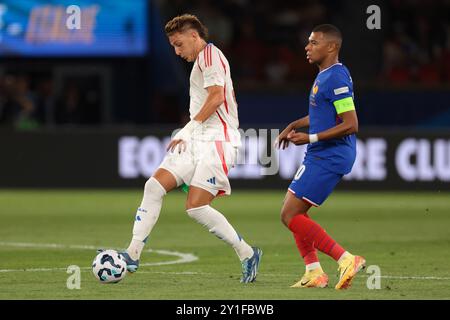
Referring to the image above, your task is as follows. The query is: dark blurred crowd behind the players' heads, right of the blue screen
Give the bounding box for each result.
[160,0,450,85]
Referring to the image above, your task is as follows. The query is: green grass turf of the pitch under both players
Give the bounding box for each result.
[0,190,450,300]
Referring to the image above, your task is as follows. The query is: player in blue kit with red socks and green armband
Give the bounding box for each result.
[276,24,365,289]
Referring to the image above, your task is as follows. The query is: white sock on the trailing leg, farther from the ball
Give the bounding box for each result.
[186,205,253,261]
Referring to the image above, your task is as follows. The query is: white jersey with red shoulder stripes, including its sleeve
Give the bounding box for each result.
[189,43,241,146]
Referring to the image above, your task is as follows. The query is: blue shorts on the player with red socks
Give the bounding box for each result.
[288,162,343,207]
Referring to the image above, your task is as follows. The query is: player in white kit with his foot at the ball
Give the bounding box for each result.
[118,14,262,283]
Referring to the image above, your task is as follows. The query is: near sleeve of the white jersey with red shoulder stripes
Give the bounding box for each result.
[198,45,225,89]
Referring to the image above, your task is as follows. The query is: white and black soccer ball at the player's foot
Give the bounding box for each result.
[92,250,127,283]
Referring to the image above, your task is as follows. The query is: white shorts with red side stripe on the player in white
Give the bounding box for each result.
[159,141,238,196]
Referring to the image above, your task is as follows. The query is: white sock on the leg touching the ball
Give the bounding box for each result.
[127,177,166,260]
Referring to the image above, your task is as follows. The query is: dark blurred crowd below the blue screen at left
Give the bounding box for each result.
[0,74,100,129]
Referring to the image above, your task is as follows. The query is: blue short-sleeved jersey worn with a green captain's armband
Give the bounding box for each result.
[304,63,356,174]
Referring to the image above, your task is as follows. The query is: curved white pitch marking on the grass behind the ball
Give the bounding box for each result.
[0,241,198,273]
